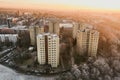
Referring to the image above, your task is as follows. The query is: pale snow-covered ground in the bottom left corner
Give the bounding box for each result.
[0,65,55,80]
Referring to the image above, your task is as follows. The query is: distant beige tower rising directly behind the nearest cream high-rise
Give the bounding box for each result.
[49,21,60,35]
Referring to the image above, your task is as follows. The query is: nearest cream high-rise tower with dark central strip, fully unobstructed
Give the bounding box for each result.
[37,33,59,67]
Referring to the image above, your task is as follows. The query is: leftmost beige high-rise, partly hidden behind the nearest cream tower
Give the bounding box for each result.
[29,26,44,45]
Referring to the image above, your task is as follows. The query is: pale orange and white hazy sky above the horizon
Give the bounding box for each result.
[0,0,120,11]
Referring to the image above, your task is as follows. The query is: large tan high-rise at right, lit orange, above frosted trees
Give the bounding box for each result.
[77,26,99,56]
